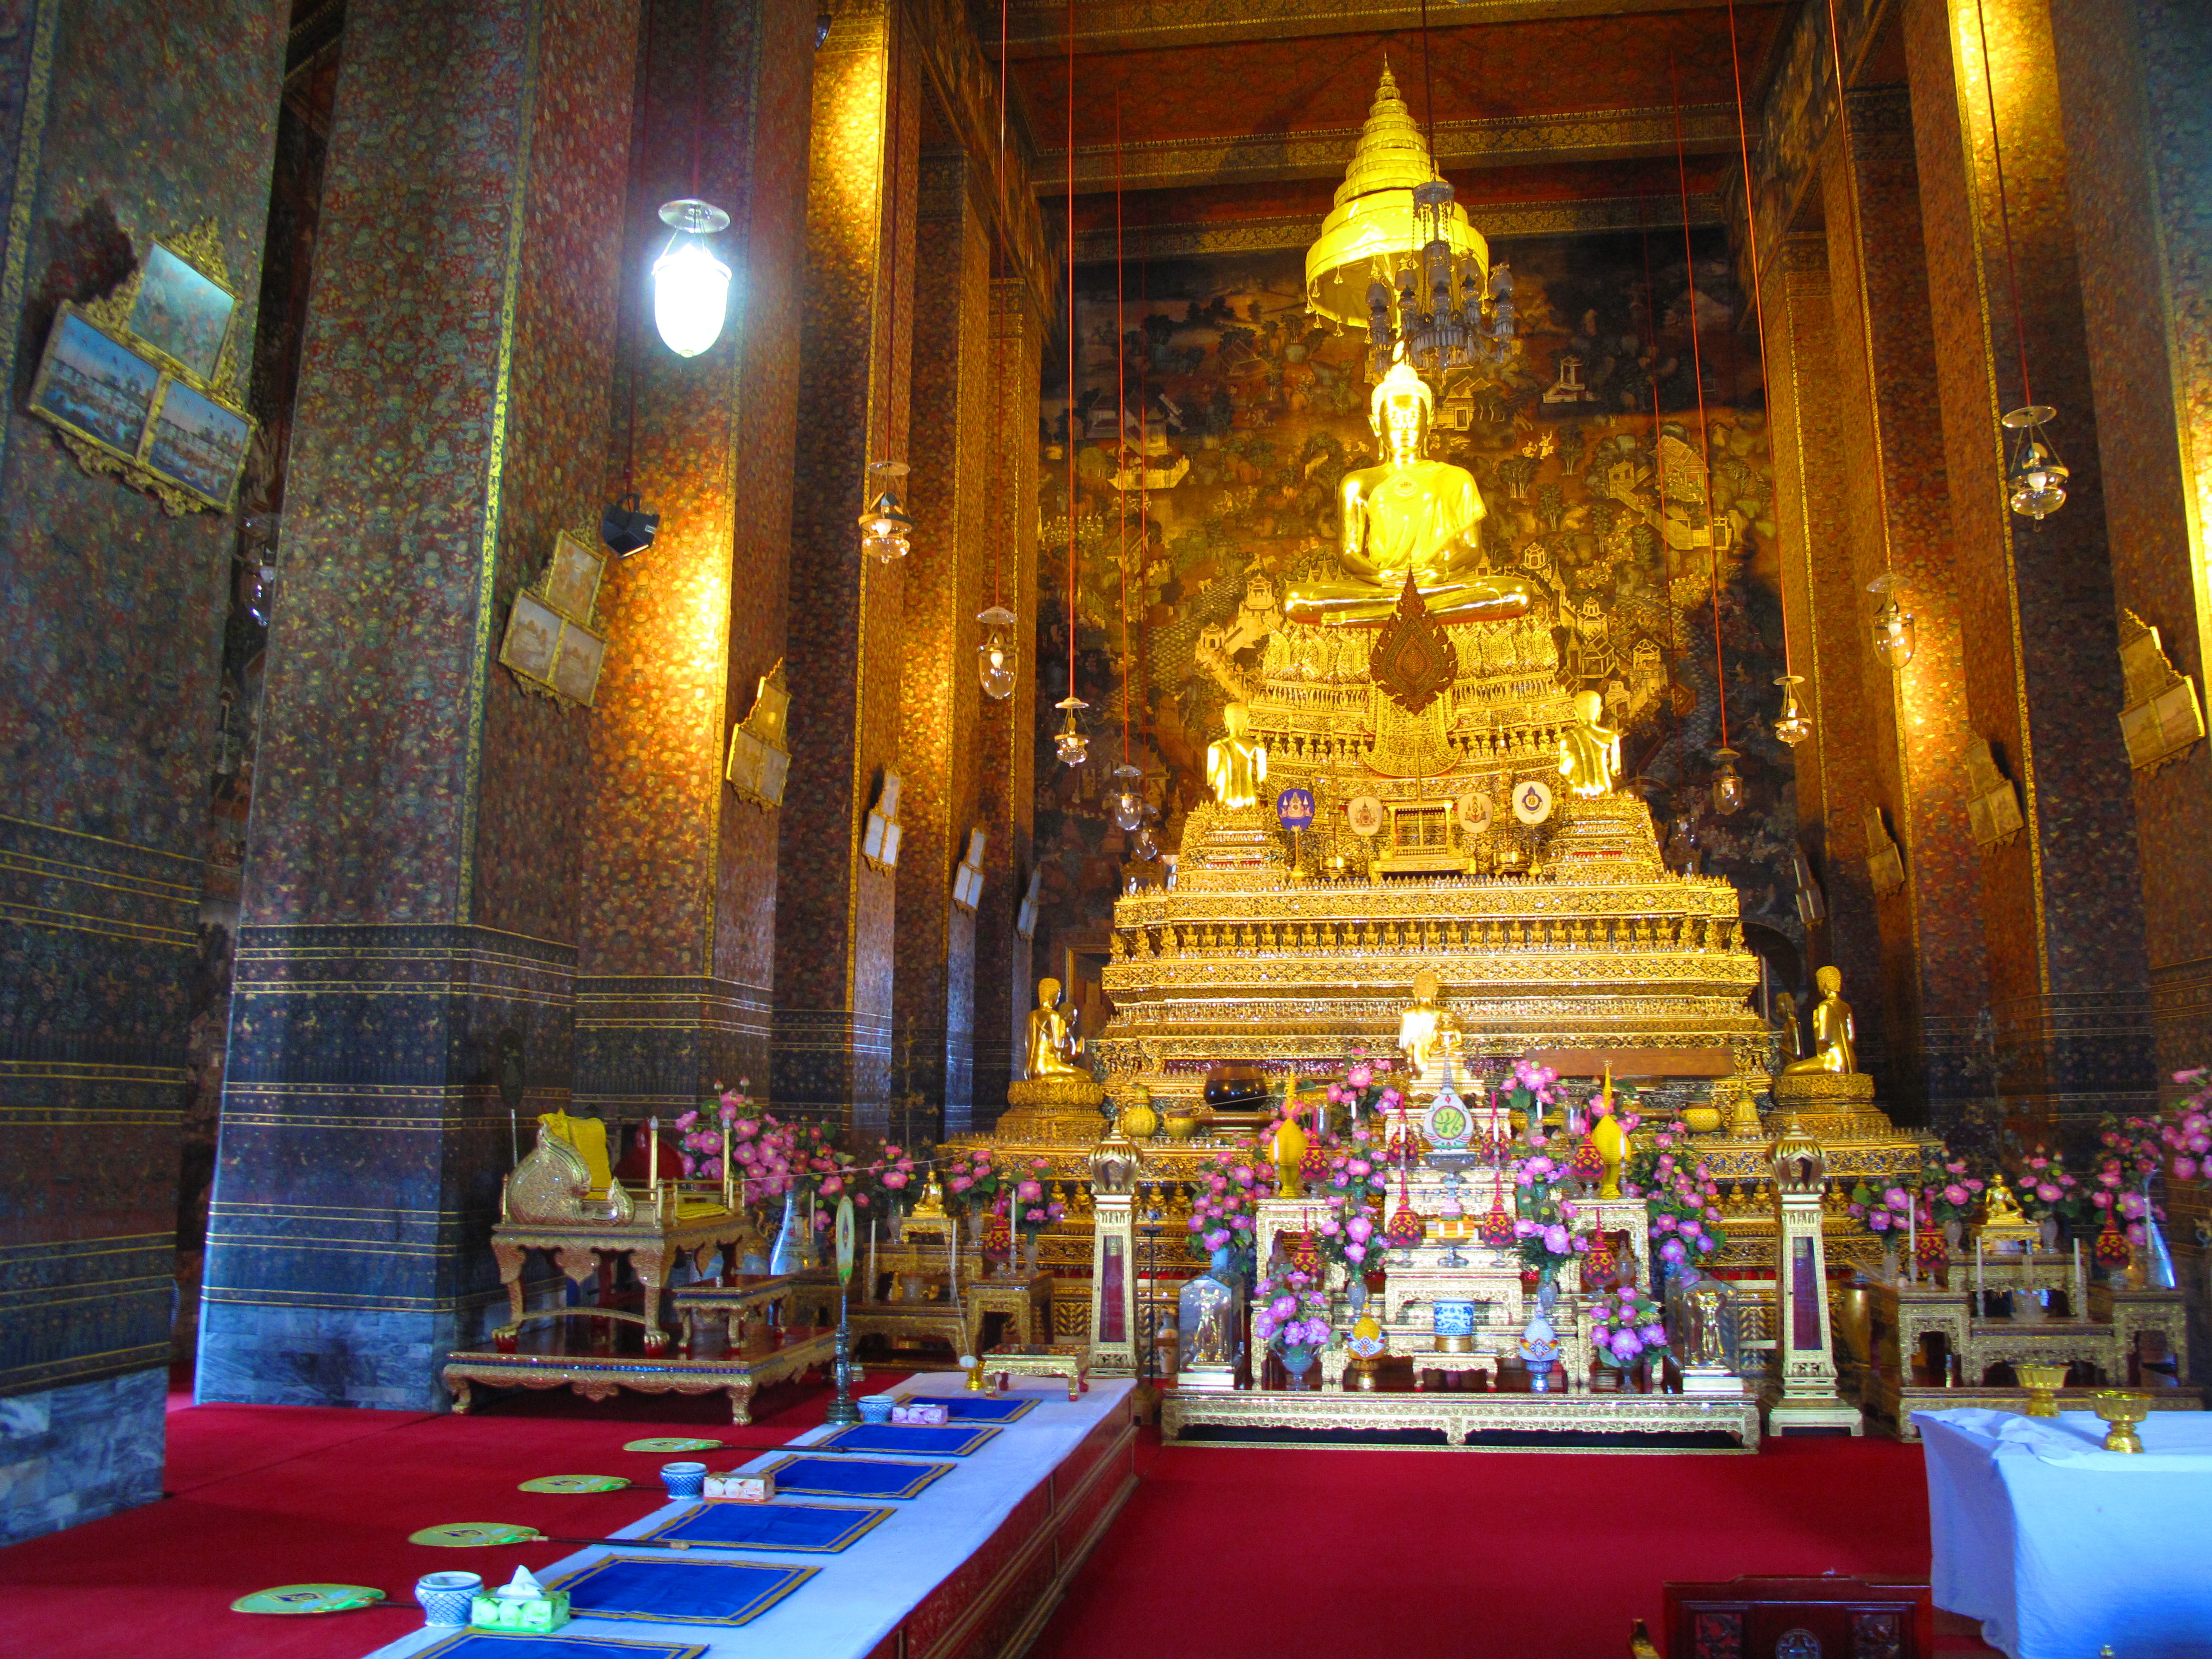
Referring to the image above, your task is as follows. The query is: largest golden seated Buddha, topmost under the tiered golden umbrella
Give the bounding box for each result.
[1283,363,1531,624]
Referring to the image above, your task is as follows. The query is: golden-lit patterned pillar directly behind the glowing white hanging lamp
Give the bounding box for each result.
[575,0,814,1119]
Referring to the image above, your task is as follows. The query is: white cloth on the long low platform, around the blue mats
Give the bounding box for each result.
[369,1371,1137,1659]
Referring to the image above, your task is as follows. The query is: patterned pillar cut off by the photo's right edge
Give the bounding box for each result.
[2051,0,2212,1083]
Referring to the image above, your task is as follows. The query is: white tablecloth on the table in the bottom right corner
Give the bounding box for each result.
[1913,1411,2212,1659]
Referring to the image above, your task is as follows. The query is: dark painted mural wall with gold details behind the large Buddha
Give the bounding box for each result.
[1037,225,1803,1022]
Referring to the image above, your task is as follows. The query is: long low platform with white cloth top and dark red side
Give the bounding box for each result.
[369,1373,1137,1659]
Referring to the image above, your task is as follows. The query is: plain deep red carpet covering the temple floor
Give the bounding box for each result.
[0,1398,2000,1659]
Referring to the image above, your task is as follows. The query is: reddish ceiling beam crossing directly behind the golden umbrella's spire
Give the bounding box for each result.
[1037,104,1737,195]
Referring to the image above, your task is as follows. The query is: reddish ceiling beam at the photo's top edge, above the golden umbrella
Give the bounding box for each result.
[993,0,1728,58]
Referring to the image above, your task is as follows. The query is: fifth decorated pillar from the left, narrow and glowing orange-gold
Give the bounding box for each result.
[894,150,991,1135]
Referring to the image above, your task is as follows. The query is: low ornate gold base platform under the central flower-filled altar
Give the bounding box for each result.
[1159,1389,1759,1449]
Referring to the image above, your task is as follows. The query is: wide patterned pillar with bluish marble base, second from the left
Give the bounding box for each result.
[199,0,637,1411]
